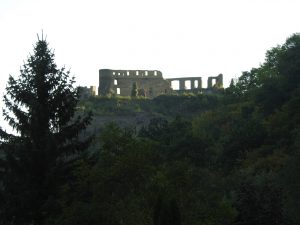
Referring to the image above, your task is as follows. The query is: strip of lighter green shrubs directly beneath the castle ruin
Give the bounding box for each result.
[79,94,223,121]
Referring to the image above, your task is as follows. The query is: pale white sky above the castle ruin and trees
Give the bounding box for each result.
[0,0,300,126]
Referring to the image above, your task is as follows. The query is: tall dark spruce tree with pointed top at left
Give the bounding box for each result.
[0,34,91,225]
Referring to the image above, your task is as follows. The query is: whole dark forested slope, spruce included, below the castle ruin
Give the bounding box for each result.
[0,34,300,225]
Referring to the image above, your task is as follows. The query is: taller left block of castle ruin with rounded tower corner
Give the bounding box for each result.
[98,69,171,97]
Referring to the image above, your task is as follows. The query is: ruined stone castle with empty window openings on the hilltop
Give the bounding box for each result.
[98,69,223,98]
